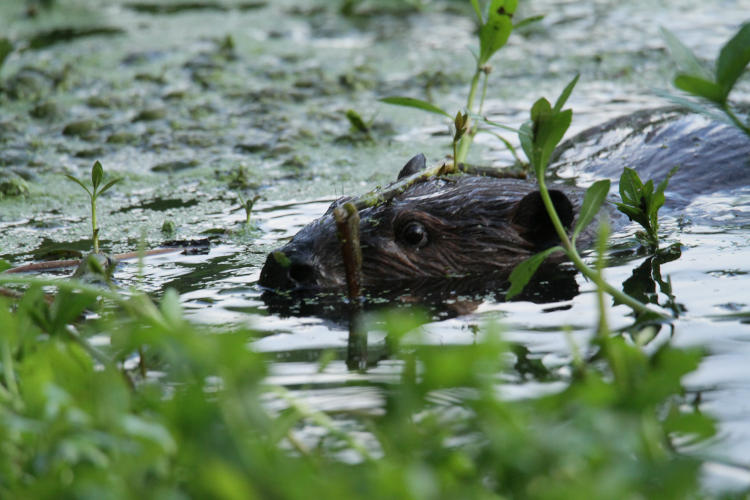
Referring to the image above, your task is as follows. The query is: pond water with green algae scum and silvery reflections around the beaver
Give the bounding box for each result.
[0,0,750,485]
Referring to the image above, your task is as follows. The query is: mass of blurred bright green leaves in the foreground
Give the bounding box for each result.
[0,282,736,499]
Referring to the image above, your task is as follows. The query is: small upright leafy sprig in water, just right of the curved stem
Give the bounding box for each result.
[616,167,677,251]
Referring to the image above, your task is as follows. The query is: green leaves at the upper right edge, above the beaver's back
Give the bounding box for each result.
[662,23,750,136]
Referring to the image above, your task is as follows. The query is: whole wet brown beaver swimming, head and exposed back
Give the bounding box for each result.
[259,109,750,291]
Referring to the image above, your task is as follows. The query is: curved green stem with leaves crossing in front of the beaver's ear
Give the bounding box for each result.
[506,75,662,316]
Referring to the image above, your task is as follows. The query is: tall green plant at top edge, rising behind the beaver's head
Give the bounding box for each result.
[381,0,542,164]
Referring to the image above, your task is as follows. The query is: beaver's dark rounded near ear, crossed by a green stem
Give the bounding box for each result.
[511,189,575,248]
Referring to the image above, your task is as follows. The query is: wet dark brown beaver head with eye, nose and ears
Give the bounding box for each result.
[259,155,579,290]
